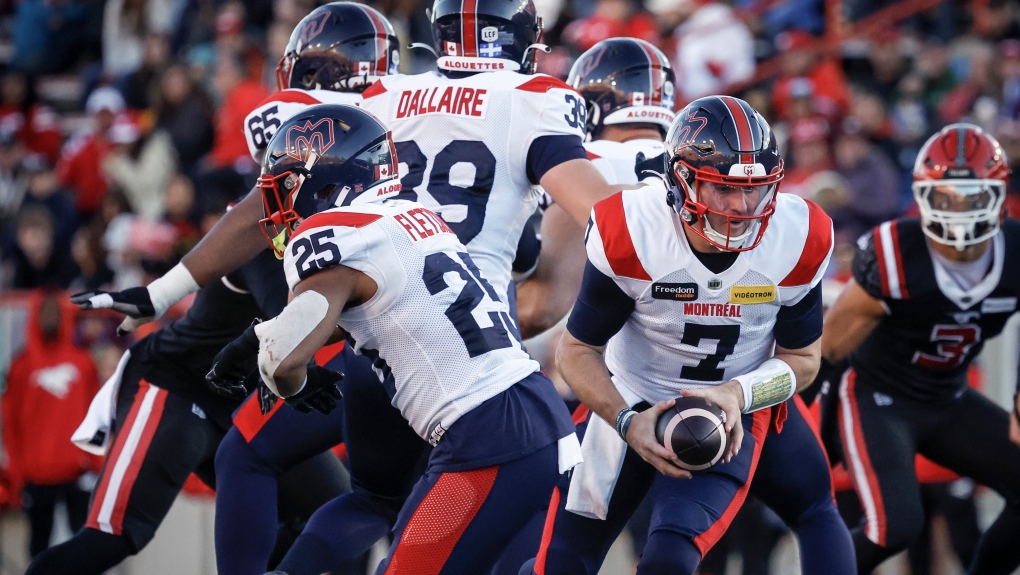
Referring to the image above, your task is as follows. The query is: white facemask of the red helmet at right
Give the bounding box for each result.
[912,178,1006,252]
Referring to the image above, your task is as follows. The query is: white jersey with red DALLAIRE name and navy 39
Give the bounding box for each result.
[360,71,584,297]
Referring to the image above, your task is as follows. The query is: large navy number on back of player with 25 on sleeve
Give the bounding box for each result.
[421,252,519,358]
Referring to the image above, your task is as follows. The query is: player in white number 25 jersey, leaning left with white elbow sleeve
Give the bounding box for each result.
[248,105,580,575]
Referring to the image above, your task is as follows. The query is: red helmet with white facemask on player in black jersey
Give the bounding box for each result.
[913,123,1010,251]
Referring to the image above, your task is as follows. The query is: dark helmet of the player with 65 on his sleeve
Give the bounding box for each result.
[276,2,400,92]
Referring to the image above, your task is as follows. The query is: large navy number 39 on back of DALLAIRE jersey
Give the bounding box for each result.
[395,140,496,245]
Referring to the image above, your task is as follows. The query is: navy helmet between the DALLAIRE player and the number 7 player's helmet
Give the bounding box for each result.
[567,38,676,138]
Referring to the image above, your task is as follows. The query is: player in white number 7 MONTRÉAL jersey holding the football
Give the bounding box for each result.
[536,96,832,574]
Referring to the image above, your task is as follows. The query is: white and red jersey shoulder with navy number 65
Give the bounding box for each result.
[244,89,361,163]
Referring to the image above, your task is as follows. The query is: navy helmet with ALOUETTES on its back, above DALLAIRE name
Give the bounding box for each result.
[426,0,549,73]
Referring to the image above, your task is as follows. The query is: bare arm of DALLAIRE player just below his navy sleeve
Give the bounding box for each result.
[539,158,622,229]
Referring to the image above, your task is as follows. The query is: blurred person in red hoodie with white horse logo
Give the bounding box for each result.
[0,290,99,557]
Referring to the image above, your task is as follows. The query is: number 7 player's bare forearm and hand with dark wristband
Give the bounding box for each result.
[556,329,691,479]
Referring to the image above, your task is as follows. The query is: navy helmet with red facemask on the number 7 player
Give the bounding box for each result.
[665,96,783,252]
